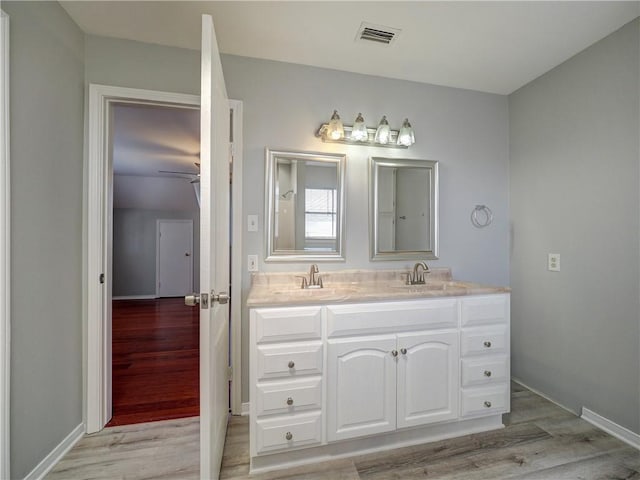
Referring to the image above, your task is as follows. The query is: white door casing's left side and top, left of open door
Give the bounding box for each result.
[83,84,200,433]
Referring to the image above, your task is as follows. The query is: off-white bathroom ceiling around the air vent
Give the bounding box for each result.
[61,1,640,94]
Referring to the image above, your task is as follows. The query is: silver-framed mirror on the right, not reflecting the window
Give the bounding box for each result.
[369,157,438,260]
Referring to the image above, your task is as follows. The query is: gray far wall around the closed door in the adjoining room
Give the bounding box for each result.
[113,208,200,297]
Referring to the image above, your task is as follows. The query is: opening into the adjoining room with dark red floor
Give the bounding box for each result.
[107,103,200,426]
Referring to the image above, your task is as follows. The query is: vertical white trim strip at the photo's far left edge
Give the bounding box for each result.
[0,10,11,478]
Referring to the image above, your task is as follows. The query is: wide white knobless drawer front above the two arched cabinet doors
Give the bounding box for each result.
[327,298,458,337]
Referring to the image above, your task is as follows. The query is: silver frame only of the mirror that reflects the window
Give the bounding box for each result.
[265,148,347,262]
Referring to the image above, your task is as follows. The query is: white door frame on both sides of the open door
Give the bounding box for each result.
[83,84,242,433]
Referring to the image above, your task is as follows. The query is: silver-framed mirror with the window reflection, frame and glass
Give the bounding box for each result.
[265,148,346,262]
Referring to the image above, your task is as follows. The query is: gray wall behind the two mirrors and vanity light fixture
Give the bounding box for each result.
[222,56,509,401]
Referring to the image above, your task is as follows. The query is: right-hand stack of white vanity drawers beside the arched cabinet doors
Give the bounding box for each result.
[460,295,511,418]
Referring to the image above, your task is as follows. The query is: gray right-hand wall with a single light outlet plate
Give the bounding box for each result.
[509,20,640,433]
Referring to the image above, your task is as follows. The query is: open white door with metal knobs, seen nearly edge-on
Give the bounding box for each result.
[200,15,230,479]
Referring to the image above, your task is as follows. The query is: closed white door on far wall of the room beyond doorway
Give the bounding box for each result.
[157,220,193,297]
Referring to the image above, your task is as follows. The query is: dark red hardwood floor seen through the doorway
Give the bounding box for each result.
[107,298,200,426]
